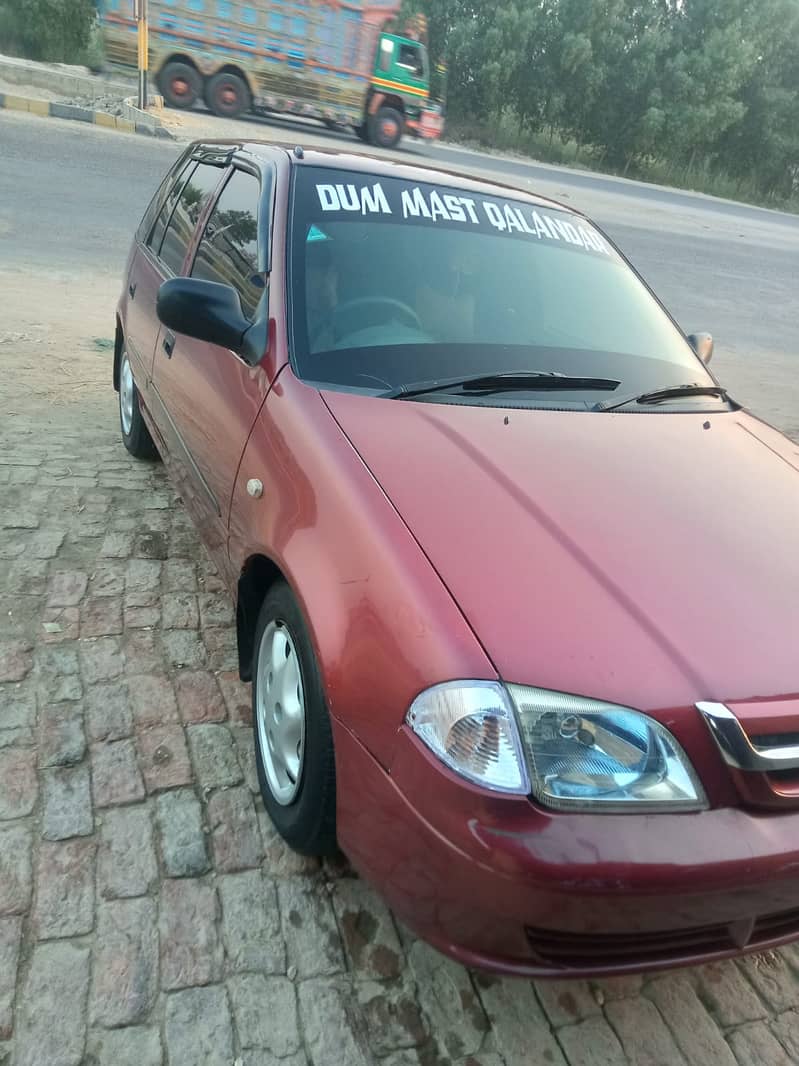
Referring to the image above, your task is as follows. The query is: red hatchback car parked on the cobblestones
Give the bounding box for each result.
[114,143,799,975]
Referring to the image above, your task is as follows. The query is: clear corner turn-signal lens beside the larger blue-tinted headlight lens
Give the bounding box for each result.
[407,681,529,795]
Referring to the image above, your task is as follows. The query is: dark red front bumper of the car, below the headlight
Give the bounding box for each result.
[333,722,799,976]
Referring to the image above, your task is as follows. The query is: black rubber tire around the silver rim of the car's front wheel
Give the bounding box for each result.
[252,582,337,855]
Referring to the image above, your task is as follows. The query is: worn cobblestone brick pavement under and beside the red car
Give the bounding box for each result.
[0,368,799,1066]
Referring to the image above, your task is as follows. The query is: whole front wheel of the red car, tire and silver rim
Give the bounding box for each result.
[252,582,336,855]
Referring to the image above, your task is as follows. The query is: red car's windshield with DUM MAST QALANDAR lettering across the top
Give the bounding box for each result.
[290,166,721,408]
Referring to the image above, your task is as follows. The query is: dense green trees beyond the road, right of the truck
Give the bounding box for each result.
[405,0,799,197]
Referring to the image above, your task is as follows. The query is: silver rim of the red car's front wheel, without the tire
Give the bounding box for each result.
[256,621,305,807]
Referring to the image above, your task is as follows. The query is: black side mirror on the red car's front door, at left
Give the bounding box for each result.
[156,277,251,355]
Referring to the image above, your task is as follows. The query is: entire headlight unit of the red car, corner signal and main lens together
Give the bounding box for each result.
[407,681,707,813]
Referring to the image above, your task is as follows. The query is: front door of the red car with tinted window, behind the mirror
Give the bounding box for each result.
[153,165,273,570]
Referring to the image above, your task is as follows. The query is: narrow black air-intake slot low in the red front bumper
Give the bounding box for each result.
[525,910,799,969]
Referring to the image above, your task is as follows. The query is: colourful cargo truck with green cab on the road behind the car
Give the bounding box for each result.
[100,0,443,148]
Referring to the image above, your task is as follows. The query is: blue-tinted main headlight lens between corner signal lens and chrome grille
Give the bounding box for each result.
[508,684,707,812]
